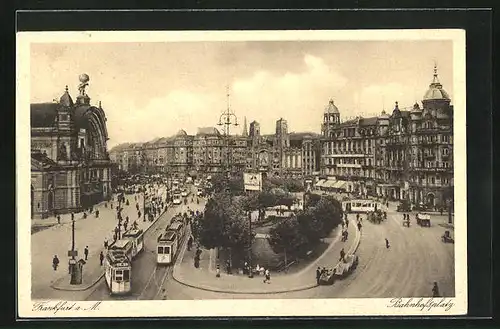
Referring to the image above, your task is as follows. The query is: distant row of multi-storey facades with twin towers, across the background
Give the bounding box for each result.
[110,119,320,179]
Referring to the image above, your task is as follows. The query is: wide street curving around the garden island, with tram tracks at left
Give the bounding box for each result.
[39,191,454,301]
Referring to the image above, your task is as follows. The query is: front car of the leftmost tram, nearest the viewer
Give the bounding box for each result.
[104,249,132,295]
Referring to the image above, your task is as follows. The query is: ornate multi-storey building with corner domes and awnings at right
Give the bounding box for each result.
[321,68,453,207]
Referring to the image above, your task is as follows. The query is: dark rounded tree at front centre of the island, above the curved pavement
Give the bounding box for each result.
[268,217,308,267]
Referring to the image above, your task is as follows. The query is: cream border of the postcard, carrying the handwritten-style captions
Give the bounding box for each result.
[16,29,467,318]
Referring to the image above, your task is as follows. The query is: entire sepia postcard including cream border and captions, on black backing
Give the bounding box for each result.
[16,30,467,317]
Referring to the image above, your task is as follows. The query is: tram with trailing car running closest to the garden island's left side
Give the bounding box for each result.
[156,216,187,265]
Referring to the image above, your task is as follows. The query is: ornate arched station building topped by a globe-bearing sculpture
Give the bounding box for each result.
[30,74,112,218]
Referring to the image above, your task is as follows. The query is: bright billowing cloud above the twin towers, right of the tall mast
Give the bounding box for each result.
[232,54,347,132]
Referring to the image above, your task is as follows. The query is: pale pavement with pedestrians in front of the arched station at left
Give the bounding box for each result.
[31,186,170,298]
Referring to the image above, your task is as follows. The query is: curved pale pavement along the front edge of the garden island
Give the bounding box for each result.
[173,217,361,294]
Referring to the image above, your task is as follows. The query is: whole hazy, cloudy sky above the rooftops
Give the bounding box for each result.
[30,41,453,148]
